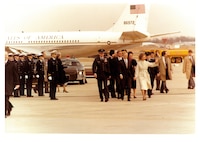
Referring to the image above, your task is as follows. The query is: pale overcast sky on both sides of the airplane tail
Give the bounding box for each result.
[5,0,195,36]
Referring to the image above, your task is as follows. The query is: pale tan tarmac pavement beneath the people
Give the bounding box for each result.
[5,64,195,134]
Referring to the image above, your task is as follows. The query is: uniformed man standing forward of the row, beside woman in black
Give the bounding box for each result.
[47,51,59,100]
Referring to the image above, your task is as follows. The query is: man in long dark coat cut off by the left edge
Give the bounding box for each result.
[5,52,19,117]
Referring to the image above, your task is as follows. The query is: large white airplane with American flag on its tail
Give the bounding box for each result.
[5,4,162,57]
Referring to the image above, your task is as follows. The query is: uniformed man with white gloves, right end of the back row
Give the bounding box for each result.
[36,54,44,96]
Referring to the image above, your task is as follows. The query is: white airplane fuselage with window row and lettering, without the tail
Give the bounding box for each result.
[6,31,134,57]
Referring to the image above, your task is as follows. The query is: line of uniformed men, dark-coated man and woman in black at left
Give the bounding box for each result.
[5,51,68,116]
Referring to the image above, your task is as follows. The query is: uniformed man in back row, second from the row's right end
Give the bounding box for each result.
[25,53,34,97]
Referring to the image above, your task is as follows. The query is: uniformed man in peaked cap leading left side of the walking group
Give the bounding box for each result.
[92,49,110,102]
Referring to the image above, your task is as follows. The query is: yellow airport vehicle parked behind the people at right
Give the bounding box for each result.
[141,49,188,63]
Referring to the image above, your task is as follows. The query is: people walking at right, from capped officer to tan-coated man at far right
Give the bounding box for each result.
[92,49,195,102]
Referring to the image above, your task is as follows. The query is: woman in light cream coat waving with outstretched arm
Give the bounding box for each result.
[134,53,157,100]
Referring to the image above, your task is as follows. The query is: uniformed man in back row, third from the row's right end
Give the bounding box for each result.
[19,54,26,96]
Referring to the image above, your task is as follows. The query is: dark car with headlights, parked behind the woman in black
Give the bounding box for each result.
[61,58,87,84]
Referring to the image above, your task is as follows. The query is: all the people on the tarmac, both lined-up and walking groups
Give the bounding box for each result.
[5,49,195,117]
